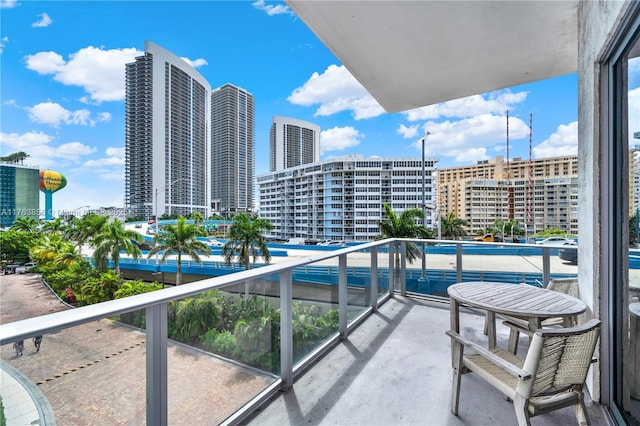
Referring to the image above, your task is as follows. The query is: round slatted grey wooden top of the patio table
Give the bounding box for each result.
[447,281,587,318]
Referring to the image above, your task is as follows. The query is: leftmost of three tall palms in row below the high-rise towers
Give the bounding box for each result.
[91,220,143,275]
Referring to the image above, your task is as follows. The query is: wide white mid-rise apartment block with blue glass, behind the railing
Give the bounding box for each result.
[257,155,438,242]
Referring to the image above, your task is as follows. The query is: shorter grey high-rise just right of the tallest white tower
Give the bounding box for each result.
[211,83,255,214]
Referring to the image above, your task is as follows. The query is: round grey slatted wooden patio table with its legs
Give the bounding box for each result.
[447,281,587,349]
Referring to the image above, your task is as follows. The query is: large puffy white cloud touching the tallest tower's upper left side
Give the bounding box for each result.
[25,46,144,103]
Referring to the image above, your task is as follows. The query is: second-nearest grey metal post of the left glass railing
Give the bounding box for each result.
[280,269,293,390]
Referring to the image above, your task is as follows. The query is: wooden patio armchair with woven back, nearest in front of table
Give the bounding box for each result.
[447,319,600,426]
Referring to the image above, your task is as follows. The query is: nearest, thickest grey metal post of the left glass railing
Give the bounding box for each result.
[146,303,168,426]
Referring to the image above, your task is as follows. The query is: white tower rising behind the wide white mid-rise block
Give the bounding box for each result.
[269,116,320,172]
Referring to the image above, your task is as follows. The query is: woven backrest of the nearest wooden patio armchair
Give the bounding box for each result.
[517,319,600,398]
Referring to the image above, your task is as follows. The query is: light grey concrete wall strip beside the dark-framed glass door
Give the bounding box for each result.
[577,1,629,401]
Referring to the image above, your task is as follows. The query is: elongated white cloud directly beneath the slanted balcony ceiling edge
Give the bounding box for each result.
[403,90,528,121]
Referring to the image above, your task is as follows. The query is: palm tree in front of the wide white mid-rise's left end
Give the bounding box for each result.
[222,213,273,269]
